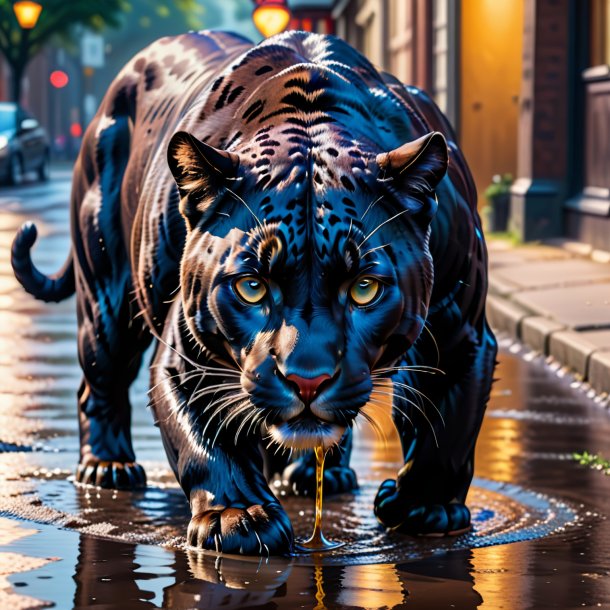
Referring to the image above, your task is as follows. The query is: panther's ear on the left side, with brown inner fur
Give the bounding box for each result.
[167,131,239,228]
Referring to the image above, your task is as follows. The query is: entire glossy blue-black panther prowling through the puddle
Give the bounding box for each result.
[12,31,497,555]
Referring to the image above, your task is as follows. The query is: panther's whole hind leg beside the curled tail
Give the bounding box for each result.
[72,103,150,489]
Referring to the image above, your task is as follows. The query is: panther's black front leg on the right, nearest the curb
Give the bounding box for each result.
[375,323,496,536]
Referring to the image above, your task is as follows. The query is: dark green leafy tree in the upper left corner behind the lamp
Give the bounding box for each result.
[0,0,202,102]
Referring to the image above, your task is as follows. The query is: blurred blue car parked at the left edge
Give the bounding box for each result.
[0,102,49,184]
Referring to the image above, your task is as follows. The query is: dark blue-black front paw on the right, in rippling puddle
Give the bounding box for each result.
[375,479,470,536]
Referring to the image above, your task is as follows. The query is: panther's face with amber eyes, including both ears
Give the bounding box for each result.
[169,128,447,448]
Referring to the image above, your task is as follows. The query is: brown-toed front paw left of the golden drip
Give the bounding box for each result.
[187,504,294,557]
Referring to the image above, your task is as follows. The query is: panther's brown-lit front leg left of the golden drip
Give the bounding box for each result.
[151,346,294,556]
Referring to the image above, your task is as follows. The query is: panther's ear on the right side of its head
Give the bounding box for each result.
[377,131,449,194]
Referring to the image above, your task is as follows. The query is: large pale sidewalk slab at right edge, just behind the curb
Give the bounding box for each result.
[512,284,610,330]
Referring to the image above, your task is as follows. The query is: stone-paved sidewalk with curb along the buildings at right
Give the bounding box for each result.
[487,239,610,394]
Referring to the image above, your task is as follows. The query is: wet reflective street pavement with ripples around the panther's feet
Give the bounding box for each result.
[0,172,610,610]
